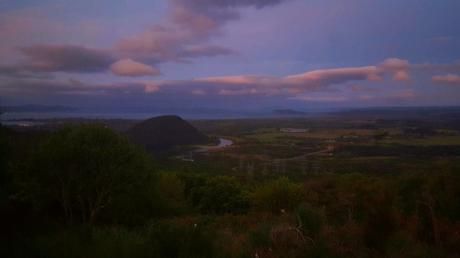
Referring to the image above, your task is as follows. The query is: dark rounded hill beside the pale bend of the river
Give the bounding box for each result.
[127,115,210,150]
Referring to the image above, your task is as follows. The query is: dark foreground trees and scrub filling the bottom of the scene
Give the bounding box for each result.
[0,125,460,257]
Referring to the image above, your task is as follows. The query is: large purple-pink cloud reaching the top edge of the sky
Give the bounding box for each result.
[115,0,283,63]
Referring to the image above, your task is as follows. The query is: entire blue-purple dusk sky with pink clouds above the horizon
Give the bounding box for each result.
[0,0,460,110]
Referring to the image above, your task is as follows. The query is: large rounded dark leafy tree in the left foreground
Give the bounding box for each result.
[28,125,152,223]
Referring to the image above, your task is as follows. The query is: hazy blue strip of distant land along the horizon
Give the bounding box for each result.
[0,105,460,120]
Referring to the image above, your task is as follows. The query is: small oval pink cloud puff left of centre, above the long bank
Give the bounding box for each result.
[110,59,160,77]
